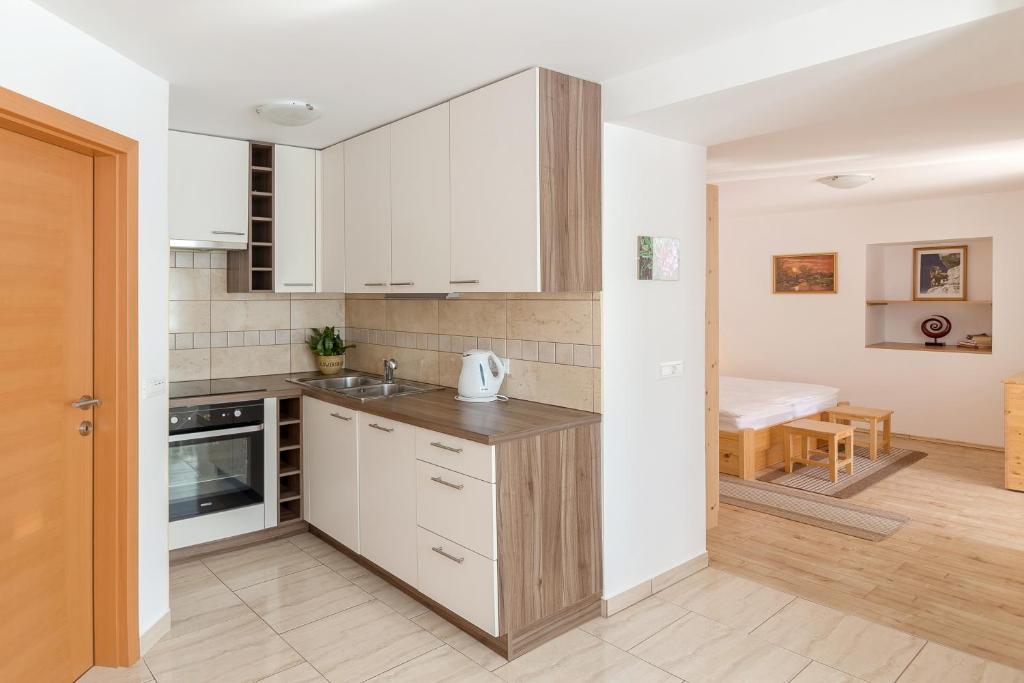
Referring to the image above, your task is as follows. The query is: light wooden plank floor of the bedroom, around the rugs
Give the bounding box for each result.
[708,439,1024,668]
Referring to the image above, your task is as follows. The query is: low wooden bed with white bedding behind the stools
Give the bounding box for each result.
[719,377,839,479]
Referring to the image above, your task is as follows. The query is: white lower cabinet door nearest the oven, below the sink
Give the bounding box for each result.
[302,396,359,552]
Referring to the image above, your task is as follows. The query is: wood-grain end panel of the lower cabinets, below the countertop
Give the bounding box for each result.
[497,425,601,633]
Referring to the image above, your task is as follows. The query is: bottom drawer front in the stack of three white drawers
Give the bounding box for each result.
[417,528,498,636]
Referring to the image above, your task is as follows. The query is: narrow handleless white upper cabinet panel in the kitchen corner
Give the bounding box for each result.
[316,142,345,292]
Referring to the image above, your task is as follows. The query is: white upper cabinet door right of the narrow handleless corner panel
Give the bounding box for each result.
[344,126,391,292]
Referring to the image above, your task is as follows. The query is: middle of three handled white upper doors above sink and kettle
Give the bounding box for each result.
[388,102,452,293]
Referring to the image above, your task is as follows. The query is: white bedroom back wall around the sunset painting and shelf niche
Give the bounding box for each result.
[721,189,1024,445]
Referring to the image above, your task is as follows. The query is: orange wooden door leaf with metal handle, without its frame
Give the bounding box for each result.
[0,129,95,681]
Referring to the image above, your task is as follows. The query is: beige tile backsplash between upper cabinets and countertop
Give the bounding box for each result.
[168,251,601,412]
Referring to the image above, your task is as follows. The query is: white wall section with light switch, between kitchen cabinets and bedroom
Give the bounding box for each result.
[601,124,706,598]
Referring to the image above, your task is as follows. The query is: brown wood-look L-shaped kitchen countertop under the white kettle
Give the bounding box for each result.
[171,373,601,444]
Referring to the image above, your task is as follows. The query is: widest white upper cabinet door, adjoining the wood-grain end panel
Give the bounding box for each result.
[450,69,541,292]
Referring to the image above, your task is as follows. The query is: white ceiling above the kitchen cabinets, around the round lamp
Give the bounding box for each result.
[35,0,839,147]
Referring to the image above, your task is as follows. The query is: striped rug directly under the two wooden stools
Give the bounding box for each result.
[758,445,928,498]
